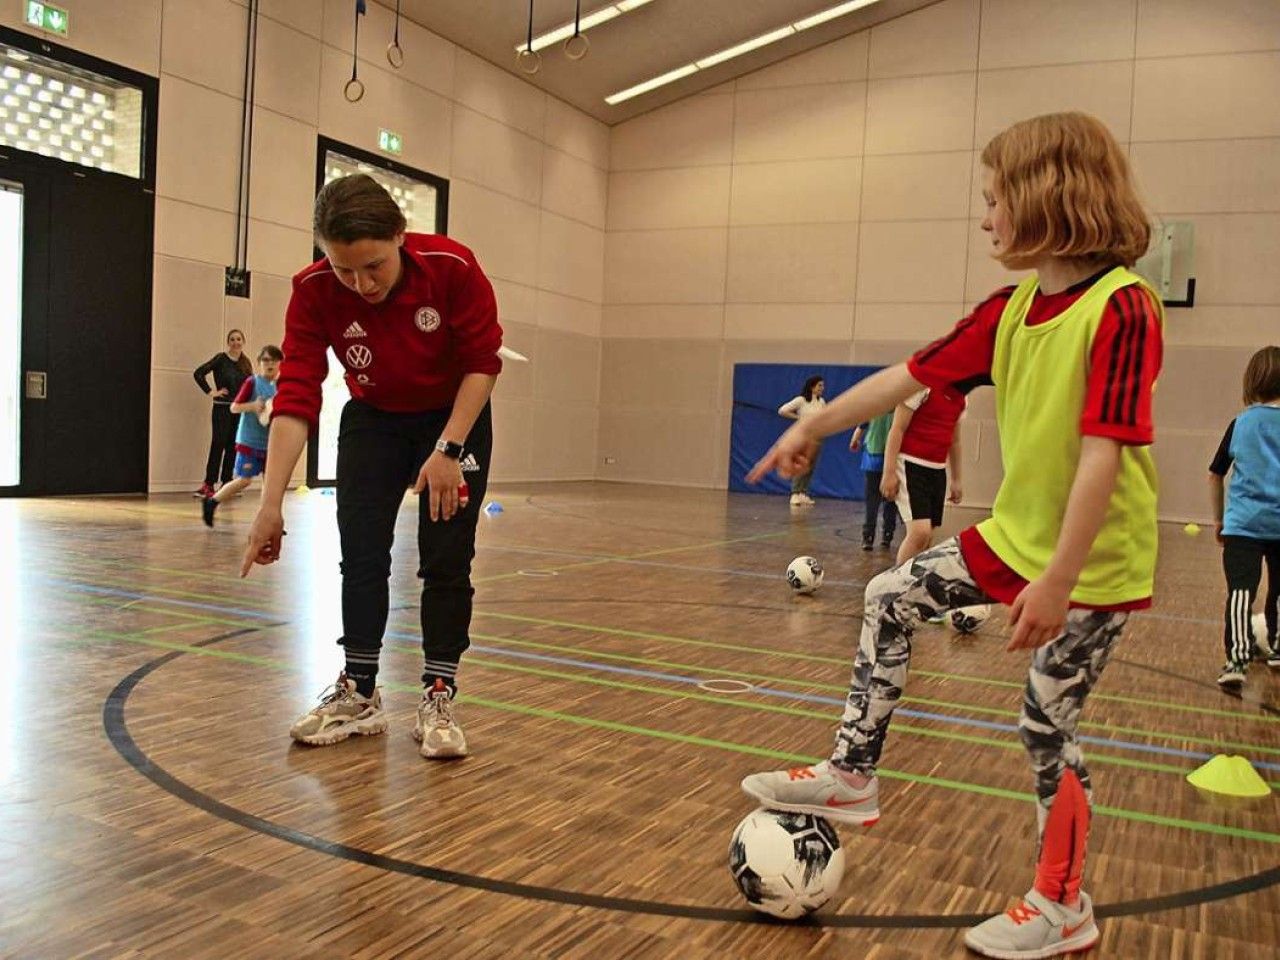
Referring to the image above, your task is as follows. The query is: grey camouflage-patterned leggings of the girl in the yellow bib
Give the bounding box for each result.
[831,538,1129,818]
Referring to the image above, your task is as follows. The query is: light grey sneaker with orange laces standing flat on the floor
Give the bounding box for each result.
[964,890,1098,960]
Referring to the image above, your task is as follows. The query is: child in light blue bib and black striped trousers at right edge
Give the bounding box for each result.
[1210,347,1280,690]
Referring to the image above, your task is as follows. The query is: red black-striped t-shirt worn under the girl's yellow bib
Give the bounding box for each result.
[908,268,1164,611]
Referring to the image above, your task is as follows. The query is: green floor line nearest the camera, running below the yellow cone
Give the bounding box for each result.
[68,632,1280,844]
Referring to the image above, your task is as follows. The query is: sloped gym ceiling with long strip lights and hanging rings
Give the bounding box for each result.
[394,0,938,124]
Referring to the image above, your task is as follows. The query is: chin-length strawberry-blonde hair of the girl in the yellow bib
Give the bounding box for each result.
[982,113,1151,270]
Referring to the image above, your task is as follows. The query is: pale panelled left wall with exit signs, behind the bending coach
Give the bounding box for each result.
[0,0,608,490]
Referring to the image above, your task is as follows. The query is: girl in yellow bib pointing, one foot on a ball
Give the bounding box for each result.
[742,113,1164,960]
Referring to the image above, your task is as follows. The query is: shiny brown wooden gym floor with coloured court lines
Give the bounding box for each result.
[0,484,1280,960]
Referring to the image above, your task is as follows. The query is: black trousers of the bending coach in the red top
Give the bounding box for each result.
[337,399,493,682]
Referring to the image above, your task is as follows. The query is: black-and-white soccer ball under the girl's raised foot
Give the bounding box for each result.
[728,809,845,920]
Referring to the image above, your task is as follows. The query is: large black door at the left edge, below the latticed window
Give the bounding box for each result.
[0,157,155,497]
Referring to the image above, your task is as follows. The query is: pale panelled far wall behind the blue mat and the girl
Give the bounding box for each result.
[598,0,1280,527]
